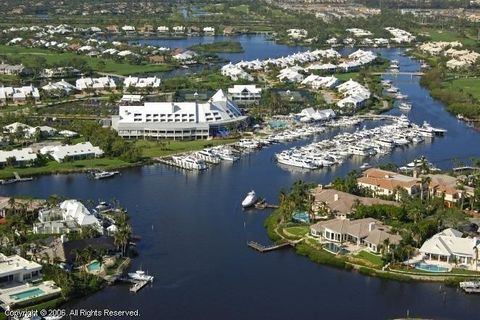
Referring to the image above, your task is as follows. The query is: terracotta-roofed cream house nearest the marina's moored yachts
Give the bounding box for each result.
[357,168,422,200]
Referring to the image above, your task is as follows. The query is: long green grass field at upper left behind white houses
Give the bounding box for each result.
[0,45,172,75]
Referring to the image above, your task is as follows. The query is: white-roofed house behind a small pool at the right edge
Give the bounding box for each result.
[420,228,480,266]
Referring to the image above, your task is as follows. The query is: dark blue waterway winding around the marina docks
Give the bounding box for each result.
[0,48,480,319]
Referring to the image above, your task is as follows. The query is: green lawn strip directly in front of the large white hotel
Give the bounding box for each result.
[136,138,237,158]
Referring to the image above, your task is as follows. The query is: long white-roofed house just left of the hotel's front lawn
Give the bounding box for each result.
[40,142,103,162]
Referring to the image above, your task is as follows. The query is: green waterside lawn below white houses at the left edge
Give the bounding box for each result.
[0,158,131,179]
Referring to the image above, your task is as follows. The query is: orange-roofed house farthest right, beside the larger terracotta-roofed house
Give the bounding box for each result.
[421,174,475,208]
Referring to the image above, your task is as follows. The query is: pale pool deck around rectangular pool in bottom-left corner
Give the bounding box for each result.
[0,281,62,306]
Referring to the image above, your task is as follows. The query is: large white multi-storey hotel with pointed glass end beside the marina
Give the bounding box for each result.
[112,90,247,139]
